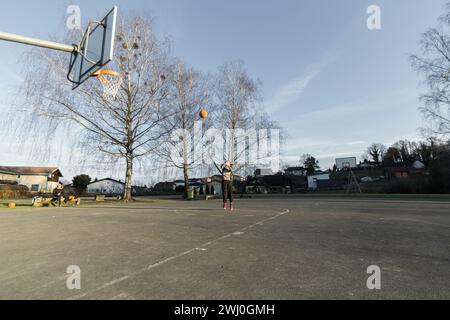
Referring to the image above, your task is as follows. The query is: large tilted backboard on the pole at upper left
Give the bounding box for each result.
[67,7,117,89]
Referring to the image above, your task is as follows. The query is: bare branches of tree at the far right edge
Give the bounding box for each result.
[411,3,450,134]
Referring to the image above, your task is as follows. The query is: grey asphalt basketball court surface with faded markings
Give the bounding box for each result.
[0,198,450,300]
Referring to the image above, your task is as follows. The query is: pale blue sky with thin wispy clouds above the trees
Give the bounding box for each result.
[0,0,445,180]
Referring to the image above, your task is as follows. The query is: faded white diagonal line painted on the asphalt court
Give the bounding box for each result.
[68,209,290,300]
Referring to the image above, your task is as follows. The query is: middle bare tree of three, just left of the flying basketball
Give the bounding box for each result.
[158,62,212,195]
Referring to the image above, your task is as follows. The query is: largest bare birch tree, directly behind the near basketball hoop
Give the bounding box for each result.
[13,17,173,201]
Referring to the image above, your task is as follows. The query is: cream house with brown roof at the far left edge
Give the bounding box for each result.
[0,166,63,193]
